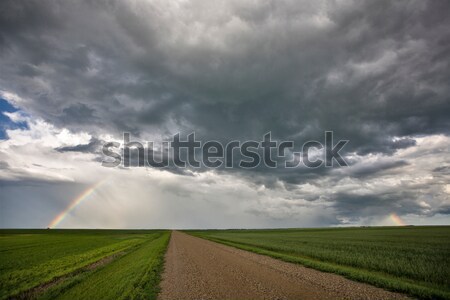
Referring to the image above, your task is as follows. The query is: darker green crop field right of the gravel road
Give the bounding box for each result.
[186,226,450,299]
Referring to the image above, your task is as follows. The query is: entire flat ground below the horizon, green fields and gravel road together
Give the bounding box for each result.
[0,226,450,300]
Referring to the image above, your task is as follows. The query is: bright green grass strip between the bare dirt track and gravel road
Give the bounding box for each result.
[38,232,170,299]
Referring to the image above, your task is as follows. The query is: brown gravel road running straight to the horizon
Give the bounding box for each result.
[159,231,406,300]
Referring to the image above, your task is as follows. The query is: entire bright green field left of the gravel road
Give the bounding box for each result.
[0,230,170,299]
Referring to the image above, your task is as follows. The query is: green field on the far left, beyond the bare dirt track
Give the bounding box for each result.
[0,230,169,299]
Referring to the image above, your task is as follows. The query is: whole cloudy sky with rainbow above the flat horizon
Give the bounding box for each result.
[0,0,450,228]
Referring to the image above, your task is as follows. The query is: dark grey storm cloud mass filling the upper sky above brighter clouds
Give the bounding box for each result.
[0,0,450,226]
